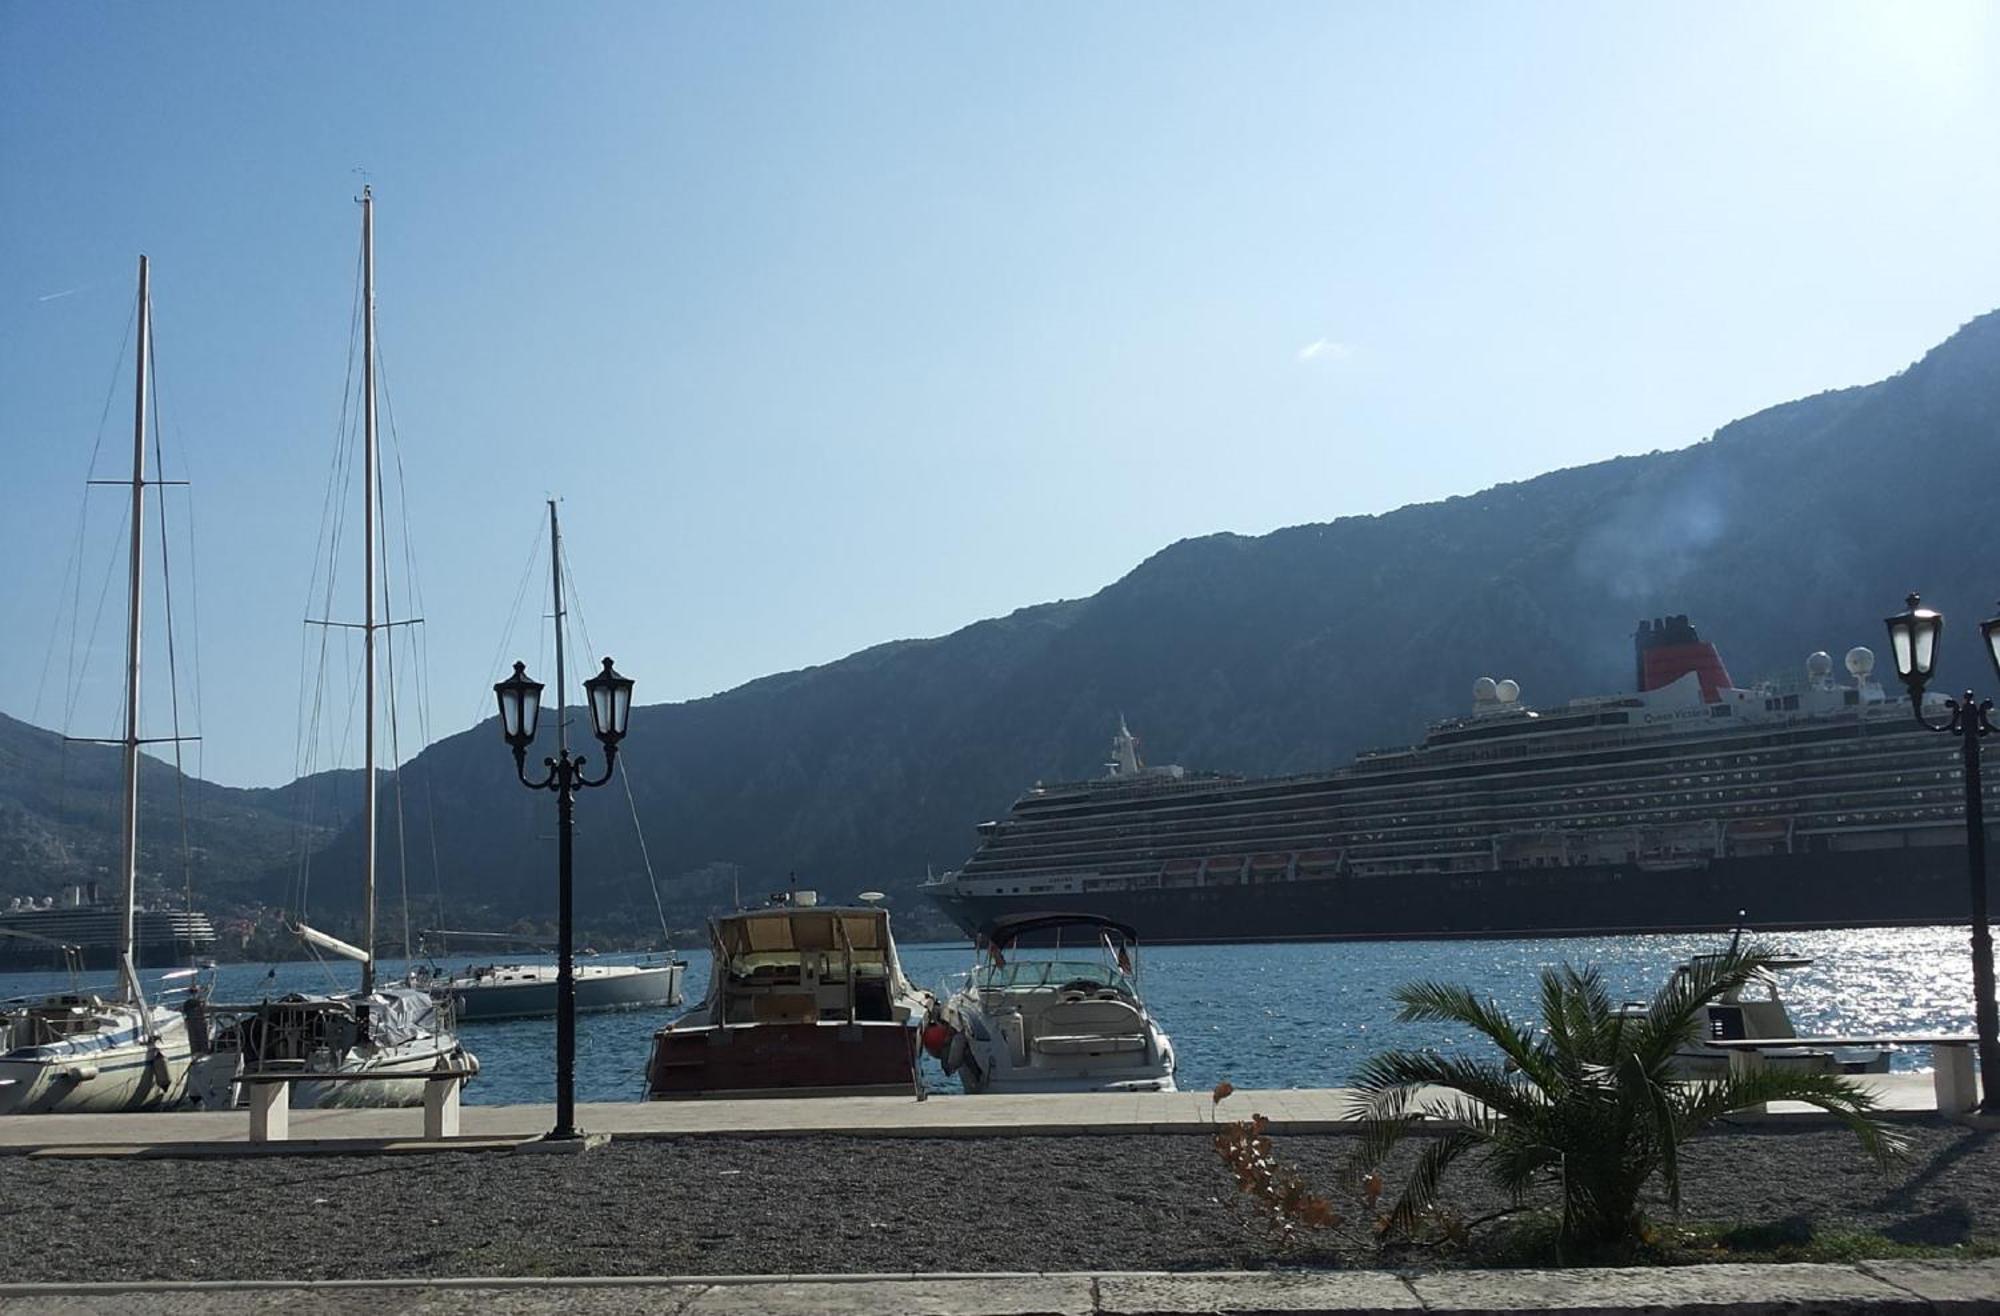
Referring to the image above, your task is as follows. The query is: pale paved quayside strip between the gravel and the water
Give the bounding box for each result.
[0,1074,1936,1154]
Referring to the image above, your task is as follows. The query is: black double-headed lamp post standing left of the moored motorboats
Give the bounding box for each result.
[494,658,632,1140]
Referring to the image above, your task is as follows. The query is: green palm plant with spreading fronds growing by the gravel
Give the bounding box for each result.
[1358,946,1902,1252]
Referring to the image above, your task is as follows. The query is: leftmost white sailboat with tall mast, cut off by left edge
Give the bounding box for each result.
[0,256,199,1114]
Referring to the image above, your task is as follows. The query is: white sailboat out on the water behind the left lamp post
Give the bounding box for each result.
[414,498,688,1022]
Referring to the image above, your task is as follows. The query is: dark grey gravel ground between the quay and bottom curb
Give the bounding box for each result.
[0,1122,2000,1280]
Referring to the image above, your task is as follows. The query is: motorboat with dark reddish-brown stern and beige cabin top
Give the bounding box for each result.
[646,890,936,1100]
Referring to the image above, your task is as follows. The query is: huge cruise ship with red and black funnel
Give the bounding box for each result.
[924,616,2000,942]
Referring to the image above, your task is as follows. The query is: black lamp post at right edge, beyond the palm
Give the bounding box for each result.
[1888,594,2000,1114]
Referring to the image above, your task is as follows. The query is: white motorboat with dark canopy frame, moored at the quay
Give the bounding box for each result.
[926,914,1174,1092]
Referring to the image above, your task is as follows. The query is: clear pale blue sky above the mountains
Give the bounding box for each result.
[0,0,2000,784]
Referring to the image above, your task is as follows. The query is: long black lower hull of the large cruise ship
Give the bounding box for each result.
[926,846,1970,944]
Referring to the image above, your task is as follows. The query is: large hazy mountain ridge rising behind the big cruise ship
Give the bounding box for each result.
[0,312,2000,944]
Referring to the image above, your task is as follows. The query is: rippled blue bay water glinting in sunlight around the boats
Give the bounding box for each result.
[0,928,1972,1104]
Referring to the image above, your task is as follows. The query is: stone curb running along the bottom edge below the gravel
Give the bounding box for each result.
[0,1262,2000,1316]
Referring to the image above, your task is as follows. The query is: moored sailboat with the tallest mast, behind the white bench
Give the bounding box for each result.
[188,188,478,1108]
